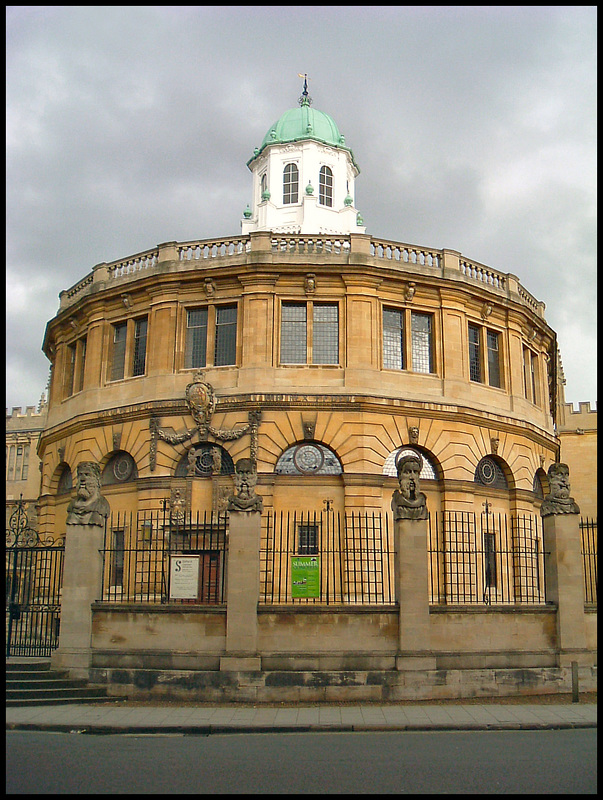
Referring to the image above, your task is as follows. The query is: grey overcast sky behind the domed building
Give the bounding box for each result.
[6,6,597,409]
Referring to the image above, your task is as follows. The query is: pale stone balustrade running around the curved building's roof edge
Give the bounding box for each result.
[59,231,545,318]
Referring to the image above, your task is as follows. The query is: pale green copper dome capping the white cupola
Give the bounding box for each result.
[247,101,358,169]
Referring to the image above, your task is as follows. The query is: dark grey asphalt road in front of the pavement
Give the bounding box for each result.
[6,728,597,794]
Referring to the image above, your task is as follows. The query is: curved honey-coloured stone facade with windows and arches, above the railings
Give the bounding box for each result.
[39,231,558,531]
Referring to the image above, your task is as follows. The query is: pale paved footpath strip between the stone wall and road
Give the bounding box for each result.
[6,701,597,735]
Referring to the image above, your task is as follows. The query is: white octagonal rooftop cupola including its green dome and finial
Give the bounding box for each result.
[241,80,366,235]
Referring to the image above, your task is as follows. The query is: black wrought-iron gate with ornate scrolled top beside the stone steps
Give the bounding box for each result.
[6,500,65,657]
